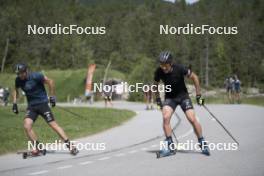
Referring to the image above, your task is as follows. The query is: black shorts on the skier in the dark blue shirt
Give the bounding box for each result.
[26,103,54,123]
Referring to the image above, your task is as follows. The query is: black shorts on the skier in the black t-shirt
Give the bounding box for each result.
[163,96,193,112]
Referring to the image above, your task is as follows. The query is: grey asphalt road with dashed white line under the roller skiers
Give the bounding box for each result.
[0,102,264,176]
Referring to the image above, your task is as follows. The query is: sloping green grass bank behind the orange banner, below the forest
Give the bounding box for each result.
[0,67,125,101]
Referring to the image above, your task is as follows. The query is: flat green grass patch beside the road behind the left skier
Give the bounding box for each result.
[0,107,135,154]
